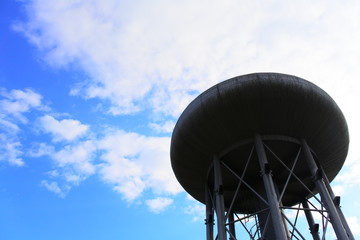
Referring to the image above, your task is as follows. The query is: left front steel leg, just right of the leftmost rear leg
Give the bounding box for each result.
[214,156,226,240]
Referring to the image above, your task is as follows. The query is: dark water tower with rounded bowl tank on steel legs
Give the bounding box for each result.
[171,73,354,240]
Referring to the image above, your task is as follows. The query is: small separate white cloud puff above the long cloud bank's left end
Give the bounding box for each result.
[38,115,89,142]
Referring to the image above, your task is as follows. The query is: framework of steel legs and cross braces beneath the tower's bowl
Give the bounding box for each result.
[205,135,354,240]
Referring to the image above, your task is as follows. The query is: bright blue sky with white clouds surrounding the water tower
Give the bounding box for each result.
[0,0,360,240]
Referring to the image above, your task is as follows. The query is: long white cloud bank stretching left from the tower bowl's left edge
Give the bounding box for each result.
[35,130,183,202]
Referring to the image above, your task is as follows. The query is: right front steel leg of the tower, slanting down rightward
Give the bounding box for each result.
[301,139,349,240]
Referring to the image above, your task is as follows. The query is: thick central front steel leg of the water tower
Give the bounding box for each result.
[255,134,288,240]
